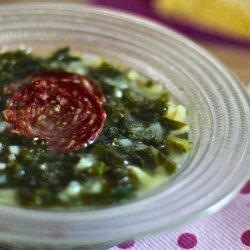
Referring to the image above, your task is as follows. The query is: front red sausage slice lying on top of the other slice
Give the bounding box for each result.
[4,79,106,153]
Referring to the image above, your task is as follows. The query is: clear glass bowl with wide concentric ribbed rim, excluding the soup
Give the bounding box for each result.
[0,4,250,249]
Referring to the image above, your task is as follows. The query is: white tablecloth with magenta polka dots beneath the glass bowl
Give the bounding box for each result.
[108,180,250,250]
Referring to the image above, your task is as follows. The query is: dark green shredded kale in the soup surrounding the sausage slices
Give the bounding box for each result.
[0,48,190,208]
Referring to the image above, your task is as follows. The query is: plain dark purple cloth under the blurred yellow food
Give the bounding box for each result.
[92,0,250,49]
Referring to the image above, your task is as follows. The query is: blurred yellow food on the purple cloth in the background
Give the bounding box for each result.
[153,0,250,39]
